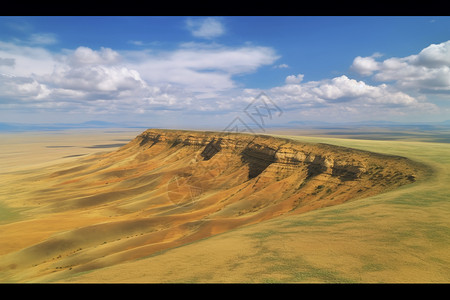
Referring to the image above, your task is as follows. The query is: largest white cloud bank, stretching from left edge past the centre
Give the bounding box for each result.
[0,42,278,113]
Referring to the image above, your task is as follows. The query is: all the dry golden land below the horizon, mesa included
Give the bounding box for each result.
[0,129,450,282]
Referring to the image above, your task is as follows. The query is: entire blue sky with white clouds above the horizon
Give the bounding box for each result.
[0,16,450,129]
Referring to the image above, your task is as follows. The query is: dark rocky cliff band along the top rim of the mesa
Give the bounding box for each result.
[135,129,416,185]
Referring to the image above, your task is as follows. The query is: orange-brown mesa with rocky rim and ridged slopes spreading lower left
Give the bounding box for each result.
[0,130,427,282]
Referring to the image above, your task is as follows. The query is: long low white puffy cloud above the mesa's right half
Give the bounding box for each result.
[227,75,437,123]
